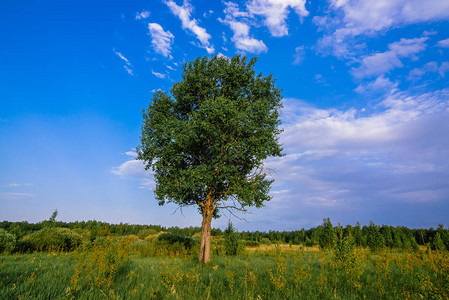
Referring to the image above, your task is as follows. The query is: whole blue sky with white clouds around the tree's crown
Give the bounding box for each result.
[0,0,449,230]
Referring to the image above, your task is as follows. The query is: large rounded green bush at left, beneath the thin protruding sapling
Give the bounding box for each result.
[21,227,83,251]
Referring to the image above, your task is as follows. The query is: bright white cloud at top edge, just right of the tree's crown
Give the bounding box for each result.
[247,0,309,37]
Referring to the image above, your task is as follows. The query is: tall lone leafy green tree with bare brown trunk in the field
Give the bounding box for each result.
[137,55,282,263]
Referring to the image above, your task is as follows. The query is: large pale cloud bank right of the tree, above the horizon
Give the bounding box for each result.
[267,86,449,221]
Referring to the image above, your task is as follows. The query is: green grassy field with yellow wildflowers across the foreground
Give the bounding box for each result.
[0,241,449,299]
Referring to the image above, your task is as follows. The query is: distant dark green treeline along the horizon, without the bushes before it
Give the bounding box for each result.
[0,217,449,252]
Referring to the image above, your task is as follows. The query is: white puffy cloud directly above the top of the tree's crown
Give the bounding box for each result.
[219,2,268,54]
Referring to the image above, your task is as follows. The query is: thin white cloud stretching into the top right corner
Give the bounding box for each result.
[313,0,449,57]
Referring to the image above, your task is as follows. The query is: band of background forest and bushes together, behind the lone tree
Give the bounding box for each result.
[0,211,449,253]
